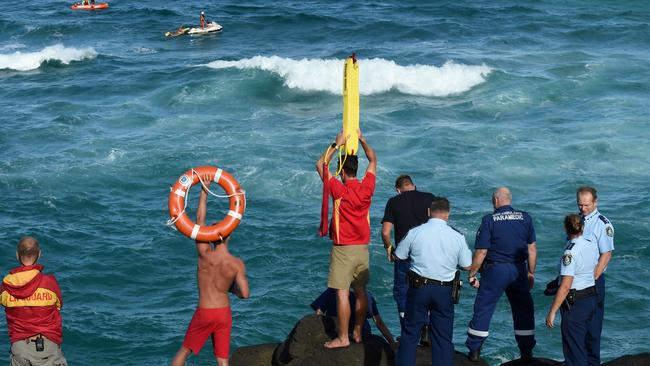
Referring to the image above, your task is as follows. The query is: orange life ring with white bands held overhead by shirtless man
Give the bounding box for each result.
[169,166,246,242]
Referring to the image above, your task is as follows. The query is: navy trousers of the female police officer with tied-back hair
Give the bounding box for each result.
[560,296,598,366]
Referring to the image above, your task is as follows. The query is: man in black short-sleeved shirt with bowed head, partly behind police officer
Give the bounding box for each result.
[381,175,434,326]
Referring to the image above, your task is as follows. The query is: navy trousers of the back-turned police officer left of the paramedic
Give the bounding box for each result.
[395,284,454,366]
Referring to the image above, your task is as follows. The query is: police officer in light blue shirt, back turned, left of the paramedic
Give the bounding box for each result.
[395,197,472,366]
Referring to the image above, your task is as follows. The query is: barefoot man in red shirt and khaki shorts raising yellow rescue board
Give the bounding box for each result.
[316,131,377,348]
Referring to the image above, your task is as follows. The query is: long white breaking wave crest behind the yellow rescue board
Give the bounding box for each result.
[204,56,492,97]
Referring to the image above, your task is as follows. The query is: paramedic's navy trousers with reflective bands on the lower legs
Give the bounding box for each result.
[465,262,535,353]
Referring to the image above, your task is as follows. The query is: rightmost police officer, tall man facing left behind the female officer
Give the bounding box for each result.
[576,186,614,365]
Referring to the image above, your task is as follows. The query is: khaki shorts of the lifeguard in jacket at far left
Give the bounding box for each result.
[11,337,68,366]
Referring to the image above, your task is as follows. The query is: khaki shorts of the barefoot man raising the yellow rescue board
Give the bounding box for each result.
[327,244,370,290]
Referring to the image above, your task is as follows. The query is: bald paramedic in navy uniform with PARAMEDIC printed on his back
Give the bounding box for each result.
[465,187,537,361]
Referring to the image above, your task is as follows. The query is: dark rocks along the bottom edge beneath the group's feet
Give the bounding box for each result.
[230,315,650,366]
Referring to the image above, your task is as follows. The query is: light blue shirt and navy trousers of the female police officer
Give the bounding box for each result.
[560,236,600,366]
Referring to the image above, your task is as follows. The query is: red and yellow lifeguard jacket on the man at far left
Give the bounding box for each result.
[0,264,63,345]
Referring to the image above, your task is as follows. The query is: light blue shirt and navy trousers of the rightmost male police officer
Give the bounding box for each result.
[583,210,614,365]
